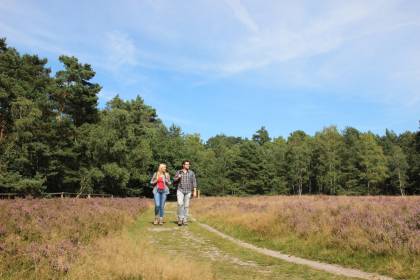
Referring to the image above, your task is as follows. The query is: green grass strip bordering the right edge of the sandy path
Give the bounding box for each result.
[196,217,420,279]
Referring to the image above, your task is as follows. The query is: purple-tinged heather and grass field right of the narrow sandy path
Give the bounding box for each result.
[193,196,420,279]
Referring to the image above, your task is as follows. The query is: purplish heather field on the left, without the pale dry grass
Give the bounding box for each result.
[0,198,149,279]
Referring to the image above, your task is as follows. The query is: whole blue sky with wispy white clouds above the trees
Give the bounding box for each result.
[0,0,420,139]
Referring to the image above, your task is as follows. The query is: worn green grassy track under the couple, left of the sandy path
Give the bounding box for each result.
[130,204,358,280]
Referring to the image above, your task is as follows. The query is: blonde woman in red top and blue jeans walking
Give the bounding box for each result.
[150,163,171,225]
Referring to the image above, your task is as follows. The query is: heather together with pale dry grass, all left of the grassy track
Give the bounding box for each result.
[0,198,215,280]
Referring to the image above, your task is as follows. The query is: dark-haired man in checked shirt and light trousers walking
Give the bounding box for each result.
[174,160,197,226]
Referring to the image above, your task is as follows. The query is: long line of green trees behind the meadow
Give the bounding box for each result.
[0,39,420,196]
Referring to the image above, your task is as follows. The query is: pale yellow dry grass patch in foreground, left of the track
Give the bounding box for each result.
[69,228,213,280]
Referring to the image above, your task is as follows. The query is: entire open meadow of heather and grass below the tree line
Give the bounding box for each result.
[0,196,420,280]
